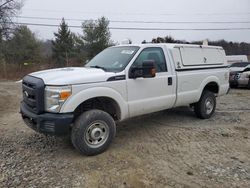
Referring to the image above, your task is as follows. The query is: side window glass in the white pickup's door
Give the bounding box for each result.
[132,47,167,72]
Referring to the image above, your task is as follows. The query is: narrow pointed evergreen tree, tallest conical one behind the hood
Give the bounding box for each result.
[52,18,75,66]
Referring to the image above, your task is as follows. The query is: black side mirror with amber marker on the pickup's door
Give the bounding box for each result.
[129,60,156,79]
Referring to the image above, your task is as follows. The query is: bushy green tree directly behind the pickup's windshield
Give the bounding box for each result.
[81,17,113,59]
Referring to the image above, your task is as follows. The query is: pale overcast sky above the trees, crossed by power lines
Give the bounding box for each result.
[16,0,250,43]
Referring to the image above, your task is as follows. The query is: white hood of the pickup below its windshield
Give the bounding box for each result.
[30,67,115,85]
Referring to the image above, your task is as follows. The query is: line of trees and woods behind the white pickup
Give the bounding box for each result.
[0,0,250,79]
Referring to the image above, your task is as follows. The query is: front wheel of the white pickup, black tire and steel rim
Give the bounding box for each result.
[71,110,116,156]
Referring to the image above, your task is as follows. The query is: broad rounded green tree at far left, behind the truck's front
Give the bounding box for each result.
[4,26,41,67]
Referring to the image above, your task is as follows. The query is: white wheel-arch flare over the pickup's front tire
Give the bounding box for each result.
[60,87,129,120]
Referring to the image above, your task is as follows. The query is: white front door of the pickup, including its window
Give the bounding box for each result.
[127,47,176,117]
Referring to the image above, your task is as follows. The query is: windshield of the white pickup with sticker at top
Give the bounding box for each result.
[85,46,139,72]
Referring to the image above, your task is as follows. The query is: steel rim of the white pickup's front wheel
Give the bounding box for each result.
[85,121,109,148]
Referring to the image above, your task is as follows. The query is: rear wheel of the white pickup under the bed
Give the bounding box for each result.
[194,90,216,119]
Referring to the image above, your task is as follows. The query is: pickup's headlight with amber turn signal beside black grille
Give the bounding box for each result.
[45,86,72,112]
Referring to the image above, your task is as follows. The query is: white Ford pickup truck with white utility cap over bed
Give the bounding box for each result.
[21,44,229,155]
